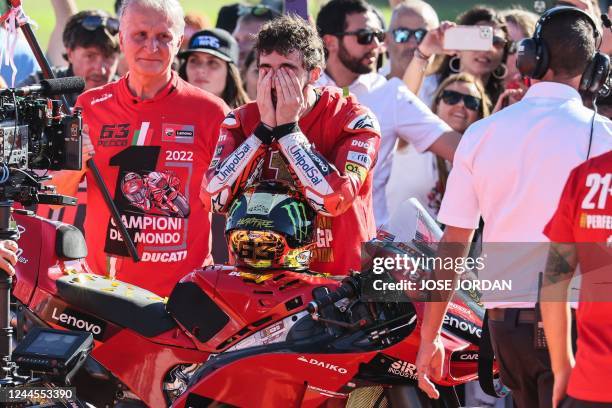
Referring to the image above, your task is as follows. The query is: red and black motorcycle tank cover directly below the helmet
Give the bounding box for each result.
[167,265,340,352]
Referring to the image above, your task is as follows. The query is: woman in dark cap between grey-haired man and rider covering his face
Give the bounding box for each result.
[179,28,249,108]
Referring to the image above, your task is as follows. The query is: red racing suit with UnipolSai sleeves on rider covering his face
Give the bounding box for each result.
[200,88,380,275]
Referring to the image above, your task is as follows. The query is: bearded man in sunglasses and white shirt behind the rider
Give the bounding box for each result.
[317,0,461,226]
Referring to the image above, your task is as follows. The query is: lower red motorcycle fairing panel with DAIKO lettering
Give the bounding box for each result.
[172,352,364,408]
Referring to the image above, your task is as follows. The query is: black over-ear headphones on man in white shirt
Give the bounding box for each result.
[516,6,610,93]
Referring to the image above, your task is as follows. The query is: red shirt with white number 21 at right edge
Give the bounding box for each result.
[544,152,612,402]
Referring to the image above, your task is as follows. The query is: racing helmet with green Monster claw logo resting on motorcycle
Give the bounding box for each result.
[225,181,316,270]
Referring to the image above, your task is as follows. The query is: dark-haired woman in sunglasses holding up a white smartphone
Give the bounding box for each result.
[404,6,511,107]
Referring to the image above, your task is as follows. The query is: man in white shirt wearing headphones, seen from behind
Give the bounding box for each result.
[416,7,612,408]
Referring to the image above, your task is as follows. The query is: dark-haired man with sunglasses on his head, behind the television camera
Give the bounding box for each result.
[19,10,119,105]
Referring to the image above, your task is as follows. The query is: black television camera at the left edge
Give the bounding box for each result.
[0,77,85,206]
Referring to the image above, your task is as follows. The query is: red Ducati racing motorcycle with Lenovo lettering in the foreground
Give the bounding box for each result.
[13,201,484,407]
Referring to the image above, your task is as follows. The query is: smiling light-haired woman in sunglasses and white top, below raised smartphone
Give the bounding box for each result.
[387,73,490,216]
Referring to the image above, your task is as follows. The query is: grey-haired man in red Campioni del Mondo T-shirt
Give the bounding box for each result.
[54,0,229,296]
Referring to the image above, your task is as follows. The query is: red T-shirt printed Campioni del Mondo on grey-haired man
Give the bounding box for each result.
[76,72,229,296]
